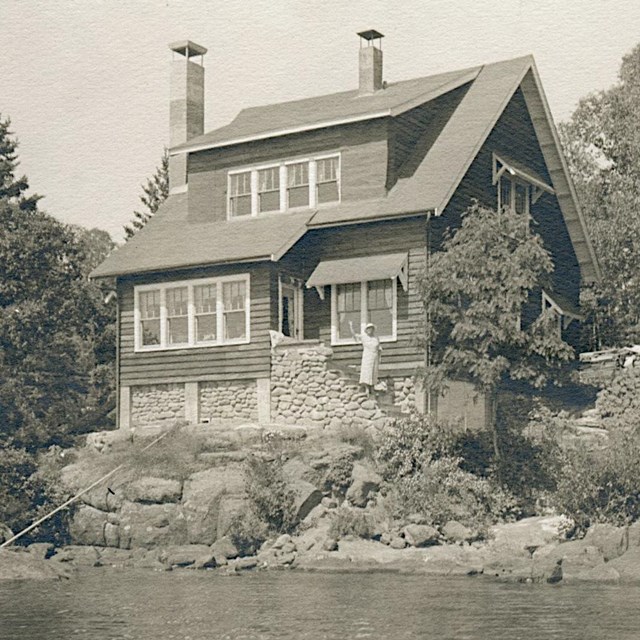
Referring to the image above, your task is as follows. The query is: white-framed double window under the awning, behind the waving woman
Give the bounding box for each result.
[331,278,397,344]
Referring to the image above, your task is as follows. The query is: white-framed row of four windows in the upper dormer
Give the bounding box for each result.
[227,154,340,218]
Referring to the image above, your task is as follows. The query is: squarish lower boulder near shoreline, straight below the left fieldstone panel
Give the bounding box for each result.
[120,502,187,549]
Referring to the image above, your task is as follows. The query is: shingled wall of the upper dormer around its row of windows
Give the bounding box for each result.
[189,120,387,221]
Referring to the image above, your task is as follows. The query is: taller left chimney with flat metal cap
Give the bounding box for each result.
[169,40,207,191]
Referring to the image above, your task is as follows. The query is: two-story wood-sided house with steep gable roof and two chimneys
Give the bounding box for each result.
[93,30,598,428]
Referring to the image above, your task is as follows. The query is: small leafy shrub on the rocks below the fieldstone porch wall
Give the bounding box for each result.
[245,456,296,533]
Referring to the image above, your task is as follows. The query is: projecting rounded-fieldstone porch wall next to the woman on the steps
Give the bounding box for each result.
[271,345,415,428]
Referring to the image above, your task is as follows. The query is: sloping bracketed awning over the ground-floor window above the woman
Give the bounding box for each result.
[307,253,407,298]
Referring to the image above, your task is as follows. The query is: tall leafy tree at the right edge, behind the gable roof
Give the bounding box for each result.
[559,45,640,348]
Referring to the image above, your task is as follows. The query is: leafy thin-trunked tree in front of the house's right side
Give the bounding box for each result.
[420,204,573,457]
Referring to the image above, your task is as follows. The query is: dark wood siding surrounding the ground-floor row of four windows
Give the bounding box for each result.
[118,263,272,386]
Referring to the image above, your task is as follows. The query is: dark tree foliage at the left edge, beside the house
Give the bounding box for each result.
[0,115,113,450]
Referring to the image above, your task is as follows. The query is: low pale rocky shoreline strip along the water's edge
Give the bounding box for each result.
[0,516,640,585]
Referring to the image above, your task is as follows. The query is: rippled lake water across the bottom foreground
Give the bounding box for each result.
[0,569,640,640]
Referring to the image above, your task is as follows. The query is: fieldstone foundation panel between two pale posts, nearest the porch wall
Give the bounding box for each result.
[199,380,258,420]
